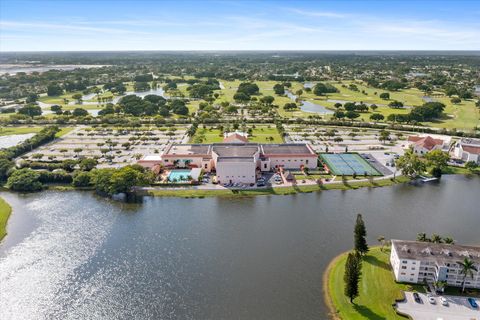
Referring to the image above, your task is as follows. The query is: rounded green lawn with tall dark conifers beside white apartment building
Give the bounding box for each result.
[325,247,423,320]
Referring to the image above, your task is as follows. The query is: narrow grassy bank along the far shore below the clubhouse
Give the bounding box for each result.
[149,176,409,198]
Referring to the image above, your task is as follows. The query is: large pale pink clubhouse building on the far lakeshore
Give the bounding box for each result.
[138,141,318,183]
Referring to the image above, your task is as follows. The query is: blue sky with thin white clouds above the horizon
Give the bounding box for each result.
[0,0,480,52]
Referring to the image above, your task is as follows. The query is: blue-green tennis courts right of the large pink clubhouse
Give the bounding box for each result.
[320,153,382,176]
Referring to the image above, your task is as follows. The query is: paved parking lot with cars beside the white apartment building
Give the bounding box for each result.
[397,292,480,320]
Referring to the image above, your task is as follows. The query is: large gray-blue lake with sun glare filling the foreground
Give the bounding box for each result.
[0,176,480,319]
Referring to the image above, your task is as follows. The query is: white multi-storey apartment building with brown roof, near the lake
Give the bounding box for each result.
[390,240,480,289]
